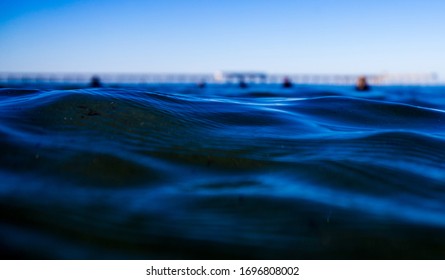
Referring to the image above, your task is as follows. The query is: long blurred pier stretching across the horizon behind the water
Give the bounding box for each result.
[0,72,439,87]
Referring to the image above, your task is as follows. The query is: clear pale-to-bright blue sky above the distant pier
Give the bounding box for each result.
[0,0,445,80]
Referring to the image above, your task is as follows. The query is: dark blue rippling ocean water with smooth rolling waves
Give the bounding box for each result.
[0,85,445,259]
